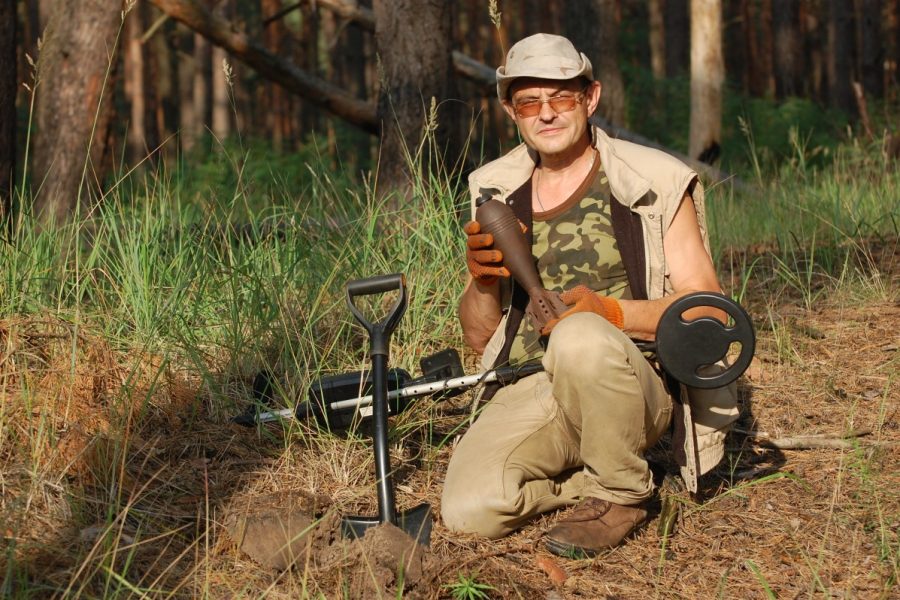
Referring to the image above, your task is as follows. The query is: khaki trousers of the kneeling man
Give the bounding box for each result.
[441,313,672,538]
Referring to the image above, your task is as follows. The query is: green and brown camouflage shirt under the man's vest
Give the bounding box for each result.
[509,160,631,363]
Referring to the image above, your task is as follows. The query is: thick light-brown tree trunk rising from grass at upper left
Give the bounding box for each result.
[32,0,121,221]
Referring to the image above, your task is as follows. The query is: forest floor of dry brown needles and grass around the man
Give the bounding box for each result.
[0,239,900,599]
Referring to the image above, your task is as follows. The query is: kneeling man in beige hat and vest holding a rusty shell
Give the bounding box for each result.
[441,34,737,556]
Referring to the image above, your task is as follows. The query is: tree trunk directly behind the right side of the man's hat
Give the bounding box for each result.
[564,0,625,127]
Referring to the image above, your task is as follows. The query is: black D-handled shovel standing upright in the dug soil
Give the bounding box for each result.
[341,273,432,546]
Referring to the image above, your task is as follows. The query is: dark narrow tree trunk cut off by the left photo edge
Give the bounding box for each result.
[0,0,19,221]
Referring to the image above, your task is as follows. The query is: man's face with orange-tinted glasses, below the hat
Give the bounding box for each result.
[503,78,600,161]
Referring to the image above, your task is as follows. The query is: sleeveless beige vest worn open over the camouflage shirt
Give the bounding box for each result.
[469,127,738,491]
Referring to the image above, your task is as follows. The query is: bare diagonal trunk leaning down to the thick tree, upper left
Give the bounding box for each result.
[150,0,378,134]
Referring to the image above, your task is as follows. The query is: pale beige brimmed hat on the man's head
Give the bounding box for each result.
[497,33,594,100]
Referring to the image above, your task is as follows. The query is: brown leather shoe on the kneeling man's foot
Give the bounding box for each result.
[547,497,647,558]
